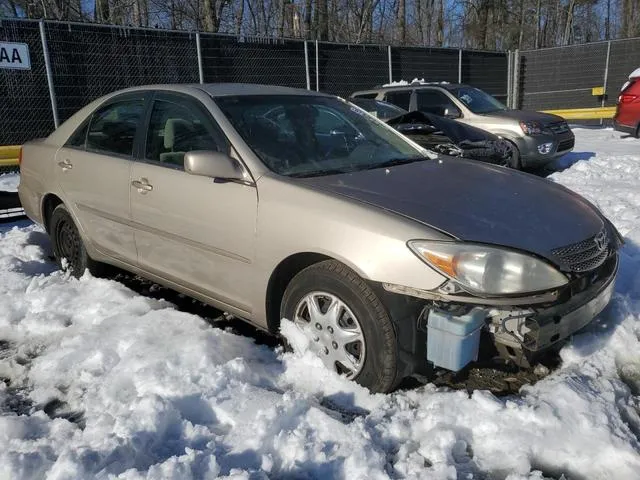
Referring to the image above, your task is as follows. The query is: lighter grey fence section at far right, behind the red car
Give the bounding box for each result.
[514,38,640,110]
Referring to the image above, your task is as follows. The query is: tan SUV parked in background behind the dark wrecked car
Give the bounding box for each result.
[351,82,575,169]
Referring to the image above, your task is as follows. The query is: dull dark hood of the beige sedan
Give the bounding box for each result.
[299,157,605,261]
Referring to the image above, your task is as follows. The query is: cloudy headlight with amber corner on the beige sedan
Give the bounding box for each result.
[408,240,567,295]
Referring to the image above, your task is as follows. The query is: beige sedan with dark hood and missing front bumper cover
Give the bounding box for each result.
[19,84,621,392]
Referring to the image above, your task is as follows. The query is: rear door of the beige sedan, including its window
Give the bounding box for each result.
[55,92,149,264]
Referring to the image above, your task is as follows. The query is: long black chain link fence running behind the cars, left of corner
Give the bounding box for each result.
[0,19,507,145]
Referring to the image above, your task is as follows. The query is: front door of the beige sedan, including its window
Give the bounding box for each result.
[130,93,258,312]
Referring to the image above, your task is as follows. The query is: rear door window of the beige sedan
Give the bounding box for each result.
[87,99,144,156]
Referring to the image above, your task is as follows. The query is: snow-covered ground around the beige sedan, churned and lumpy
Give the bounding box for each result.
[0,129,640,480]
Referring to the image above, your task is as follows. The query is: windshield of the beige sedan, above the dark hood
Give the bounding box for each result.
[216,95,426,177]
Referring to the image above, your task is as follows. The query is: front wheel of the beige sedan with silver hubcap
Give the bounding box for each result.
[280,260,400,392]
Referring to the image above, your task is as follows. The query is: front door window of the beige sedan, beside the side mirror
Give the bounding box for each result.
[145,99,221,167]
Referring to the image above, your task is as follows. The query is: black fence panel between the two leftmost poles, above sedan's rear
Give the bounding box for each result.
[46,23,198,121]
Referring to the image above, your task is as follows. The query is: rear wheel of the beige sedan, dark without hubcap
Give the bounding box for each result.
[49,204,104,278]
